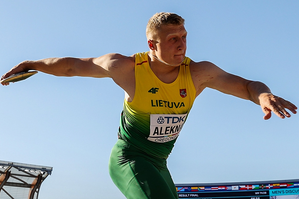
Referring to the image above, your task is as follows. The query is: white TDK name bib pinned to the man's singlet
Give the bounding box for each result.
[147,113,187,143]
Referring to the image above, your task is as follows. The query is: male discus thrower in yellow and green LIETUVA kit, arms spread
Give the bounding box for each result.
[2,13,297,199]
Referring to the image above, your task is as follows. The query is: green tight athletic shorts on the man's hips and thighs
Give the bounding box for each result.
[109,139,178,199]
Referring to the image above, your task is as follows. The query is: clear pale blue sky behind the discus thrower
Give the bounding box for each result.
[0,0,299,199]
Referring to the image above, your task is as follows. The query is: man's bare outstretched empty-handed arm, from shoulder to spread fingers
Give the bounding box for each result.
[191,62,297,120]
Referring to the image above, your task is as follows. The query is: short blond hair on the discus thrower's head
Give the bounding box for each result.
[146,12,185,37]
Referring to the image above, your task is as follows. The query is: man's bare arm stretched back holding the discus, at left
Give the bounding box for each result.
[1,54,134,85]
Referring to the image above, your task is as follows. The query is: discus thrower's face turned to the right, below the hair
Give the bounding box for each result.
[155,25,187,65]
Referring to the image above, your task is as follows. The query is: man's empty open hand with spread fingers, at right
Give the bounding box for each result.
[259,93,297,120]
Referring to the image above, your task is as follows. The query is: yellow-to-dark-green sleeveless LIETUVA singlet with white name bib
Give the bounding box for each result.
[120,52,196,158]
